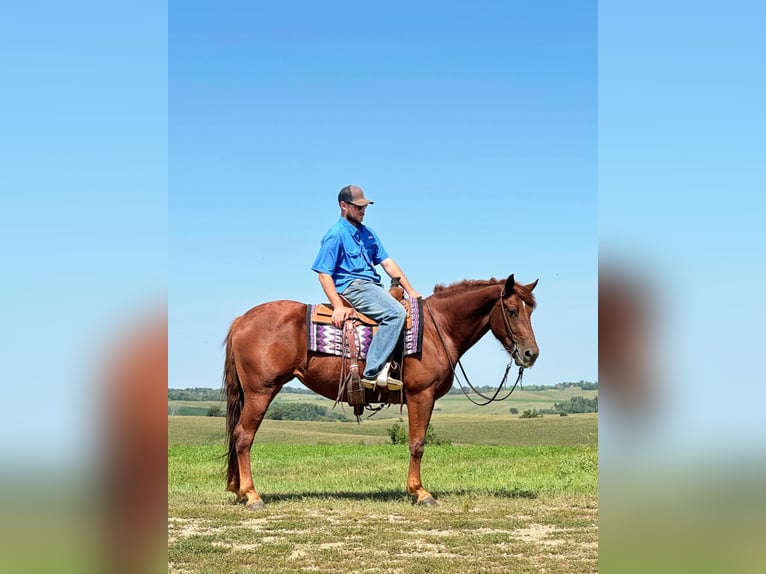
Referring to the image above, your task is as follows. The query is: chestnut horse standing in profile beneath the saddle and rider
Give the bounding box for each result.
[223,275,539,510]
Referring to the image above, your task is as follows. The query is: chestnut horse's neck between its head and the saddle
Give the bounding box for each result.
[432,285,502,356]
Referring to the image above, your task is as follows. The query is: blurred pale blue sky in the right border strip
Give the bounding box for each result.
[598,1,766,462]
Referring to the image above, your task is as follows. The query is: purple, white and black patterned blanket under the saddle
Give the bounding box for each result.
[306,299,423,359]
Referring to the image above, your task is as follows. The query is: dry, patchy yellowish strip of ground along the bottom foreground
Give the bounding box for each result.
[168,497,598,574]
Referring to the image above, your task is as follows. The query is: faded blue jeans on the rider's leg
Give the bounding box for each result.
[342,279,407,378]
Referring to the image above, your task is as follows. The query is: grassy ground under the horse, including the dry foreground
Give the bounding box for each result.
[168,414,598,574]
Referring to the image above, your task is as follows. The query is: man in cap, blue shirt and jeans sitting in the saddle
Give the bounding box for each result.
[312,185,420,391]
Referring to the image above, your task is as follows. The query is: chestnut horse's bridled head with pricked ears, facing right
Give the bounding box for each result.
[489,274,540,367]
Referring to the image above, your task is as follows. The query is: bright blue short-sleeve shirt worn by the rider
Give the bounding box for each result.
[311,217,388,293]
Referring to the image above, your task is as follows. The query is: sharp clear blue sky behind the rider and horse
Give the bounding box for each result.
[168,2,597,394]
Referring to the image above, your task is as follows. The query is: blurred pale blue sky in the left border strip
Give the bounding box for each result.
[0,0,168,468]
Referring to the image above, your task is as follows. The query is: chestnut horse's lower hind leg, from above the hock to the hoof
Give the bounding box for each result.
[233,385,281,510]
